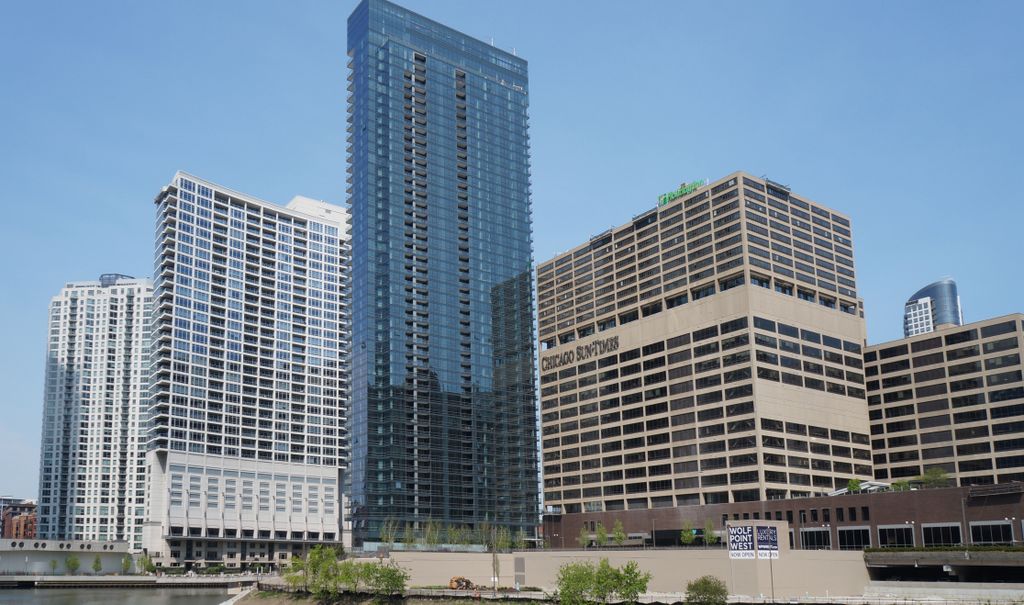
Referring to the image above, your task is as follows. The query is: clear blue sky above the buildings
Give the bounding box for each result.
[0,0,1024,498]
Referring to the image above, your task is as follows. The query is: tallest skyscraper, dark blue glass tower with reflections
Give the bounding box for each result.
[348,0,538,544]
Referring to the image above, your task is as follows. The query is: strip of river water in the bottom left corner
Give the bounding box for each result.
[0,589,230,605]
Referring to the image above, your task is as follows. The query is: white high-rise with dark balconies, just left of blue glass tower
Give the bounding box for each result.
[143,173,349,566]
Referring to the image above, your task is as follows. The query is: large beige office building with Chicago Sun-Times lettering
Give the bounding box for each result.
[538,172,872,513]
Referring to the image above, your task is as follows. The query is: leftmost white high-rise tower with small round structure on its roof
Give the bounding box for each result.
[38,274,153,549]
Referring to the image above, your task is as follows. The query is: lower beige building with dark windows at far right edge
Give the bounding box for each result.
[864,313,1024,485]
